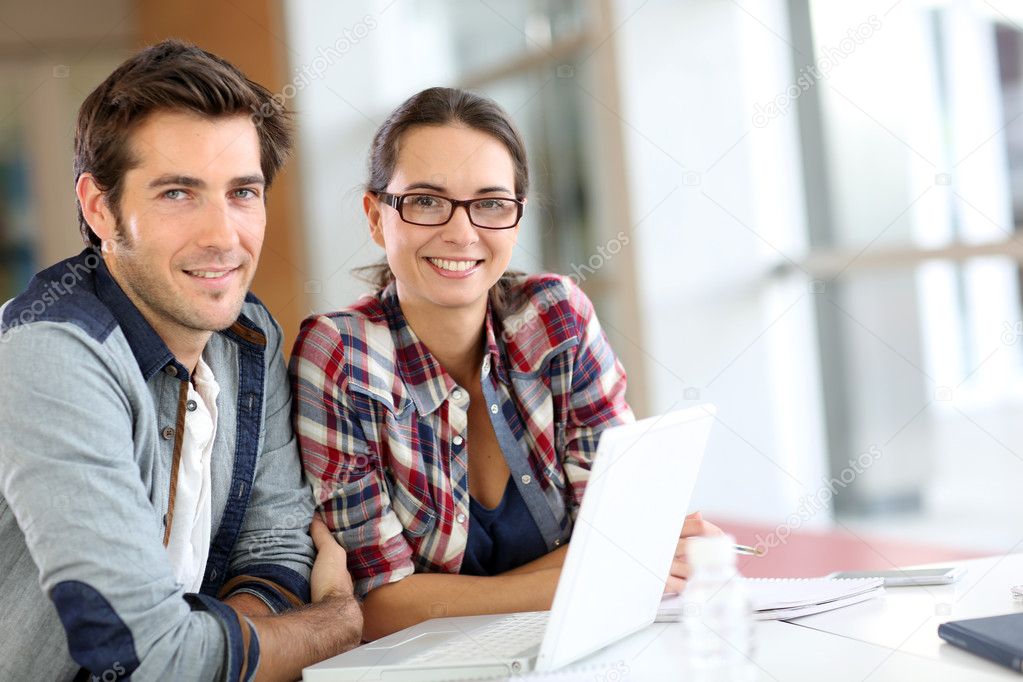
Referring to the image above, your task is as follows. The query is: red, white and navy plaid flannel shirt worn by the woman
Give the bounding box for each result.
[291,275,633,597]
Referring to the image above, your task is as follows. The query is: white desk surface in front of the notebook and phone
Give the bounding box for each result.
[517,554,1023,682]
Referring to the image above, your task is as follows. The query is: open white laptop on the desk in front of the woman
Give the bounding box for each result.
[303,405,714,682]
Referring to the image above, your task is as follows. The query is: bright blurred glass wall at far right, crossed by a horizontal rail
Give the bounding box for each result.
[800,1,1023,546]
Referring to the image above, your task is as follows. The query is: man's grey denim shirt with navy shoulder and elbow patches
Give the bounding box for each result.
[0,249,313,680]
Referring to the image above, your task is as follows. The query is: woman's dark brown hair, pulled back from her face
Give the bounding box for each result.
[355,88,529,318]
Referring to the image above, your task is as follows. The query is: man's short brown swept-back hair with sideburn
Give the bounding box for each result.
[75,40,292,246]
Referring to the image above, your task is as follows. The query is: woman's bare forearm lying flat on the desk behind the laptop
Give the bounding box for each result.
[362,555,562,641]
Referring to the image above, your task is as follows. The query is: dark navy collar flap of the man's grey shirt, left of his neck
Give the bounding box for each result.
[96,252,188,381]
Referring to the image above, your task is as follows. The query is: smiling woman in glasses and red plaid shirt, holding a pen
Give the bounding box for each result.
[292,88,716,640]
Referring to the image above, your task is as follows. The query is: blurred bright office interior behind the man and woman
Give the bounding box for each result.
[0,0,1023,575]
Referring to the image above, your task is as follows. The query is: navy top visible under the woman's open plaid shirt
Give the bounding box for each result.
[460,476,547,576]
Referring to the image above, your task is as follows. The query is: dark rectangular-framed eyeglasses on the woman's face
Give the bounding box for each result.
[376,192,525,230]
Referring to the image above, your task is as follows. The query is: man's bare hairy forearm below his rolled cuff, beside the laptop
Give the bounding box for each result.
[244,596,362,681]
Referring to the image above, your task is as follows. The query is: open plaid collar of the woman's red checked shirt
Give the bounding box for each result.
[380,282,508,415]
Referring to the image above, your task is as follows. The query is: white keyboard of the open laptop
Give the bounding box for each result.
[406,611,549,664]
